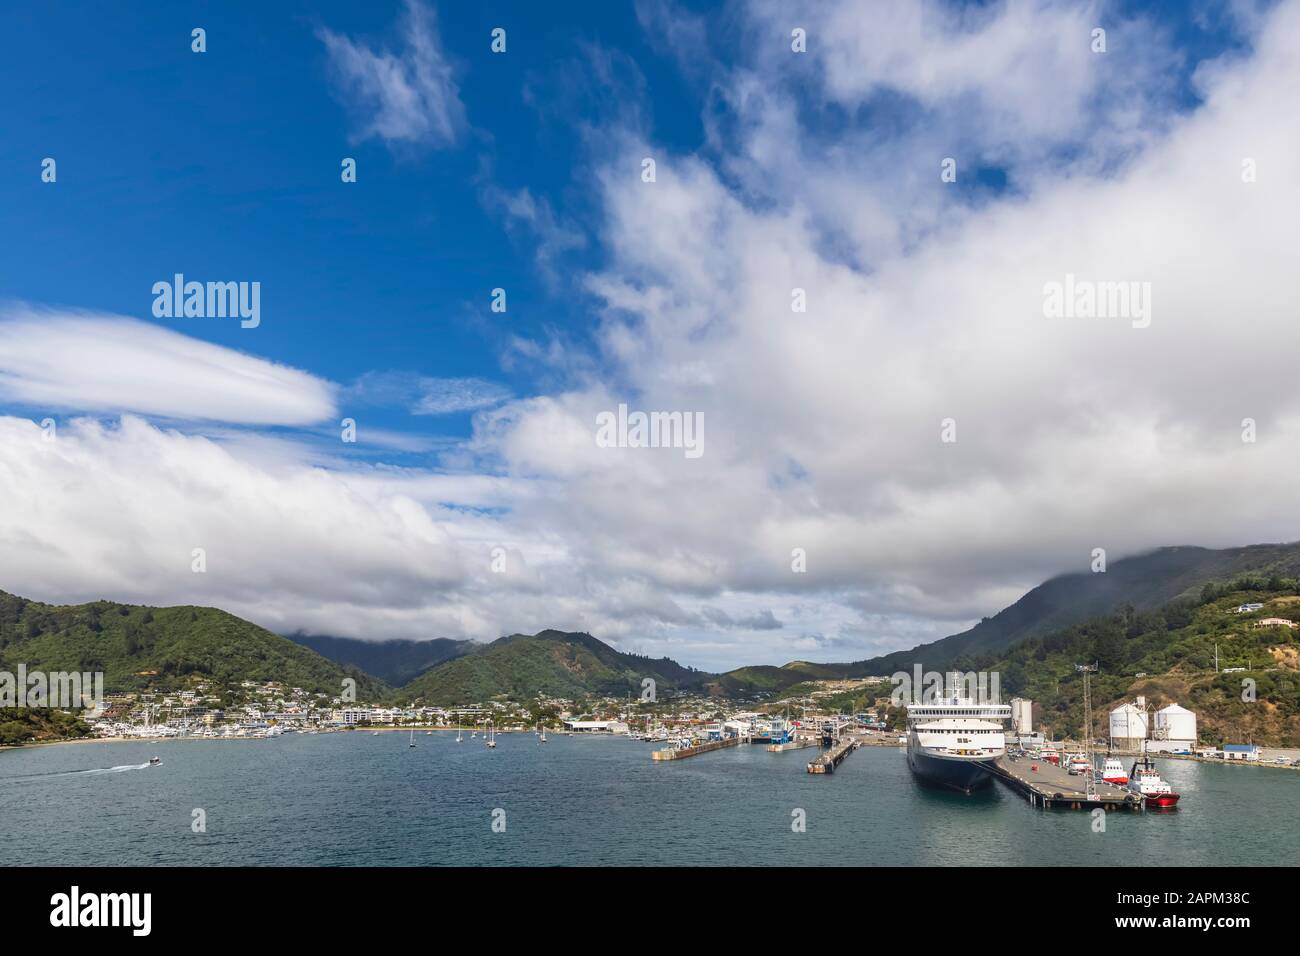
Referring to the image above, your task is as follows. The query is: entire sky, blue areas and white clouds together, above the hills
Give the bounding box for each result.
[0,0,1300,667]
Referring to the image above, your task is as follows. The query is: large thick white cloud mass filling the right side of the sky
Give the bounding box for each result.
[489,4,1300,658]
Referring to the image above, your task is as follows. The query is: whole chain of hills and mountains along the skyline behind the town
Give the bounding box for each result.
[0,544,1300,704]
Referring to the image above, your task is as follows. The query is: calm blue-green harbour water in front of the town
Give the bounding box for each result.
[0,732,1300,866]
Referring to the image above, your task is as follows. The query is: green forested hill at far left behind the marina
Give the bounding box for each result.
[0,591,387,698]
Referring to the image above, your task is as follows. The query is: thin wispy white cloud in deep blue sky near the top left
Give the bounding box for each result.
[317,0,465,147]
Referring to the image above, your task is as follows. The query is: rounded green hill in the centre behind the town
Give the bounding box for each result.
[400,631,712,704]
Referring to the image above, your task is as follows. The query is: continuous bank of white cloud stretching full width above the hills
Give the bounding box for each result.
[0,3,1300,666]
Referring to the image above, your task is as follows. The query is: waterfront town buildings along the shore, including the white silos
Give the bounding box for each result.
[76,678,1300,767]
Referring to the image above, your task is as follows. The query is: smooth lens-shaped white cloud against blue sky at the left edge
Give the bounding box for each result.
[0,306,334,425]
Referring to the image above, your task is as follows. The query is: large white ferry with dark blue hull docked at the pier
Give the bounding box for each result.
[907,680,1011,793]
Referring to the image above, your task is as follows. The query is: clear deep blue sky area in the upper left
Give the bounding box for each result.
[0,3,699,447]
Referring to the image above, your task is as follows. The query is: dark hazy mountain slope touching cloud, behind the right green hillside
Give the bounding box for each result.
[842,544,1300,676]
